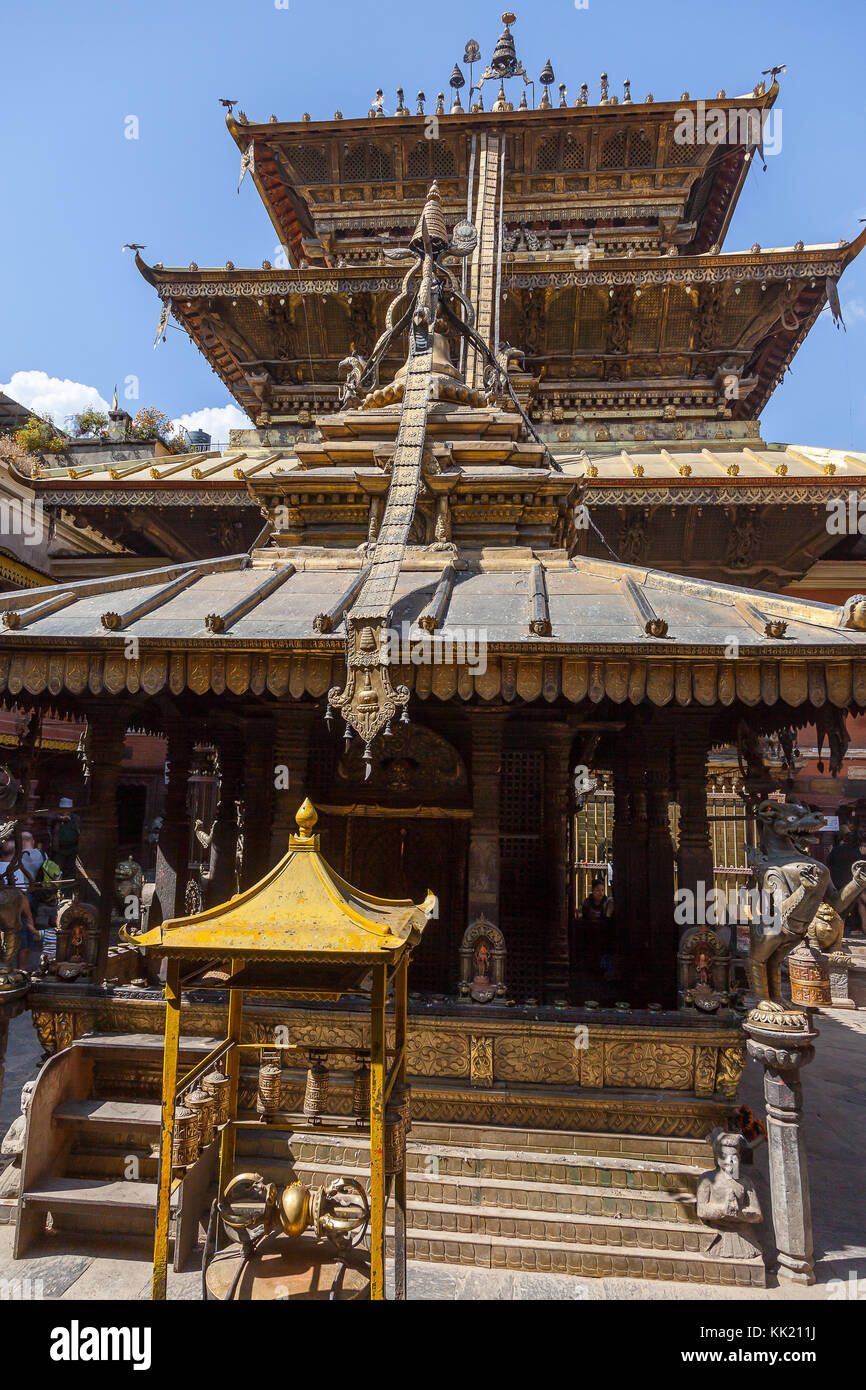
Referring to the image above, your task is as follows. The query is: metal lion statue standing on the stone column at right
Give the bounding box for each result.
[748,801,866,1011]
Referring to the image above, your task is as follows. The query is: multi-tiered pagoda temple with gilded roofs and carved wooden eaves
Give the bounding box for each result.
[0,17,866,1283]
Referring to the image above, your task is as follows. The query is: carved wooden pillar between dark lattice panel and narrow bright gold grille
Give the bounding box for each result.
[544,724,574,1004]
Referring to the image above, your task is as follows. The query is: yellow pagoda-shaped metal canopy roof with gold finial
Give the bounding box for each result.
[128,801,436,990]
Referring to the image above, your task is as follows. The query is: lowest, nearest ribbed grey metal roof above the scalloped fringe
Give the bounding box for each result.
[0,546,863,650]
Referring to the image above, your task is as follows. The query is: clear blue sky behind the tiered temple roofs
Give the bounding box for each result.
[0,0,866,449]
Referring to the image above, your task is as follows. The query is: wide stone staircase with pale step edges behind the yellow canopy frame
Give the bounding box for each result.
[238,1122,766,1287]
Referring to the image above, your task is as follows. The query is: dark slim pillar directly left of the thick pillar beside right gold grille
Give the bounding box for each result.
[644,721,677,1008]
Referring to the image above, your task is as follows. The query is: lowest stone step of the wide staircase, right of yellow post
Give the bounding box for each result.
[386,1234,766,1289]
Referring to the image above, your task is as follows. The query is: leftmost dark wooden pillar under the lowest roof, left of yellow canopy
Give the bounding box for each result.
[78,703,129,981]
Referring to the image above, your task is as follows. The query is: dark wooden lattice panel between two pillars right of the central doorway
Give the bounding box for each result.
[499,749,549,998]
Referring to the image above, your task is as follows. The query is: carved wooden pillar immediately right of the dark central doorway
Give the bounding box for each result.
[468,709,507,928]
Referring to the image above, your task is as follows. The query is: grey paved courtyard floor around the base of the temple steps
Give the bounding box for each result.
[0,1008,866,1302]
